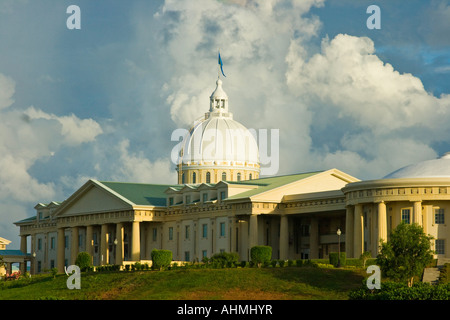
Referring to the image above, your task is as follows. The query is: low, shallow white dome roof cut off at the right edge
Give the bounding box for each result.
[383,152,450,179]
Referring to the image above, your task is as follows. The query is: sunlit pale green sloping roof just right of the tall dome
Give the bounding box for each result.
[226,171,323,200]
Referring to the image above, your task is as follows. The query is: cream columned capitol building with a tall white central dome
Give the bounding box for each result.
[8,79,450,273]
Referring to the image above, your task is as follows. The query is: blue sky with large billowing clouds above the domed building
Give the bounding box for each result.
[0,0,450,248]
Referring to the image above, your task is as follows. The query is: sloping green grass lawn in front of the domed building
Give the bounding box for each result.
[0,267,365,300]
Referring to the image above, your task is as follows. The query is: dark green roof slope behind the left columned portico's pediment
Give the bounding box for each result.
[99,181,178,207]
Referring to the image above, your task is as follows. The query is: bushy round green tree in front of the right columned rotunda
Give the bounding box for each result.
[377,223,433,287]
